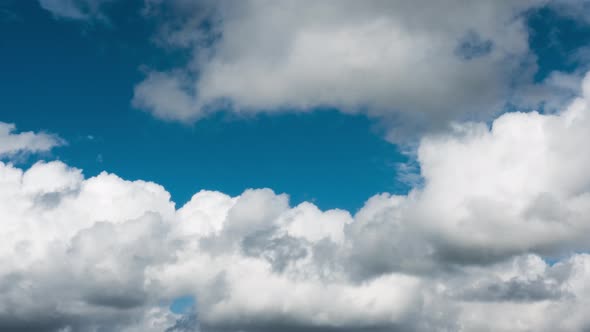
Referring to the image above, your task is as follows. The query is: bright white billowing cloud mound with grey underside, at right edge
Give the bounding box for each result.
[418,72,590,251]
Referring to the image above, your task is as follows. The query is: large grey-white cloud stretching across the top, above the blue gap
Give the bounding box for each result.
[133,0,579,135]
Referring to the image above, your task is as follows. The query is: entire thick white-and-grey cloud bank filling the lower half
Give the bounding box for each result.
[0,73,590,332]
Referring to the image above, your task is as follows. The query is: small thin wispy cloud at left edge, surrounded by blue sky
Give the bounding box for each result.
[0,122,65,158]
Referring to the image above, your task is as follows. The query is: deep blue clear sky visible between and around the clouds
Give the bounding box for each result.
[0,1,590,211]
